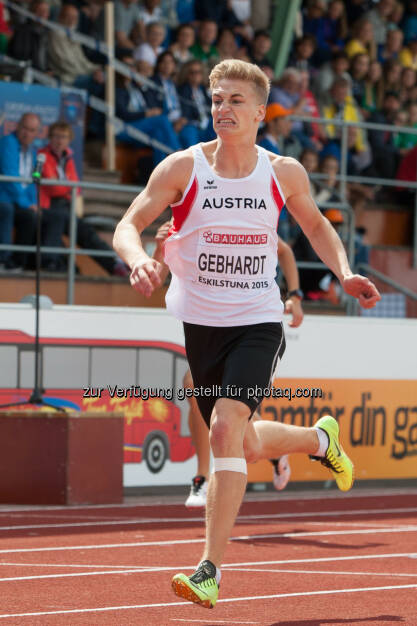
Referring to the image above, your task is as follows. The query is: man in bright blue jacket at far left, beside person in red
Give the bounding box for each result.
[0,113,41,270]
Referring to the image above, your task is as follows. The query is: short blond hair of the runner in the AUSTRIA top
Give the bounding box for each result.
[209,59,270,104]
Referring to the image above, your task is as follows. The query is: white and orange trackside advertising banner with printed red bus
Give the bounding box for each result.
[0,304,417,486]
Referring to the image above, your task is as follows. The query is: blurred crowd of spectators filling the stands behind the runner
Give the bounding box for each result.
[0,0,417,292]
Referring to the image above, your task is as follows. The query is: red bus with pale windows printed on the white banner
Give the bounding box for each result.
[0,330,195,473]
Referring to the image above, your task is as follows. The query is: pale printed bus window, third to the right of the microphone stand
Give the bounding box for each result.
[136,348,174,389]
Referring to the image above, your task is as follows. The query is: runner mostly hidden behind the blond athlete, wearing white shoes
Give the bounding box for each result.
[152,221,304,508]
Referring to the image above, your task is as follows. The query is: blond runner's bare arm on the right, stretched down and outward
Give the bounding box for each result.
[273,157,381,309]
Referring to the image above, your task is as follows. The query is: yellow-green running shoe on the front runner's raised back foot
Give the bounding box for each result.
[310,415,354,491]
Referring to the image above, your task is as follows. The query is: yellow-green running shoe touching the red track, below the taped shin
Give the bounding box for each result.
[172,561,219,609]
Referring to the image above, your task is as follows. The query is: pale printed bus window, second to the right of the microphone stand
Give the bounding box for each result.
[90,347,136,387]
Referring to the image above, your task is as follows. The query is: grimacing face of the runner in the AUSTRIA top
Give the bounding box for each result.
[211,78,265,136]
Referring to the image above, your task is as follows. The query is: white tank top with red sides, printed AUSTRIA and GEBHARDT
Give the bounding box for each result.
[165,144,285,326]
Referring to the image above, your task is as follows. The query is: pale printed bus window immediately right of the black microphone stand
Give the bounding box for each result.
[42,346,89,389]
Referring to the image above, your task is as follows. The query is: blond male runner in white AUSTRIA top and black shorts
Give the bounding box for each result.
[114,59,380,608]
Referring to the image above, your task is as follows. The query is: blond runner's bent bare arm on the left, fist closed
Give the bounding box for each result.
[113,150,193,297]
